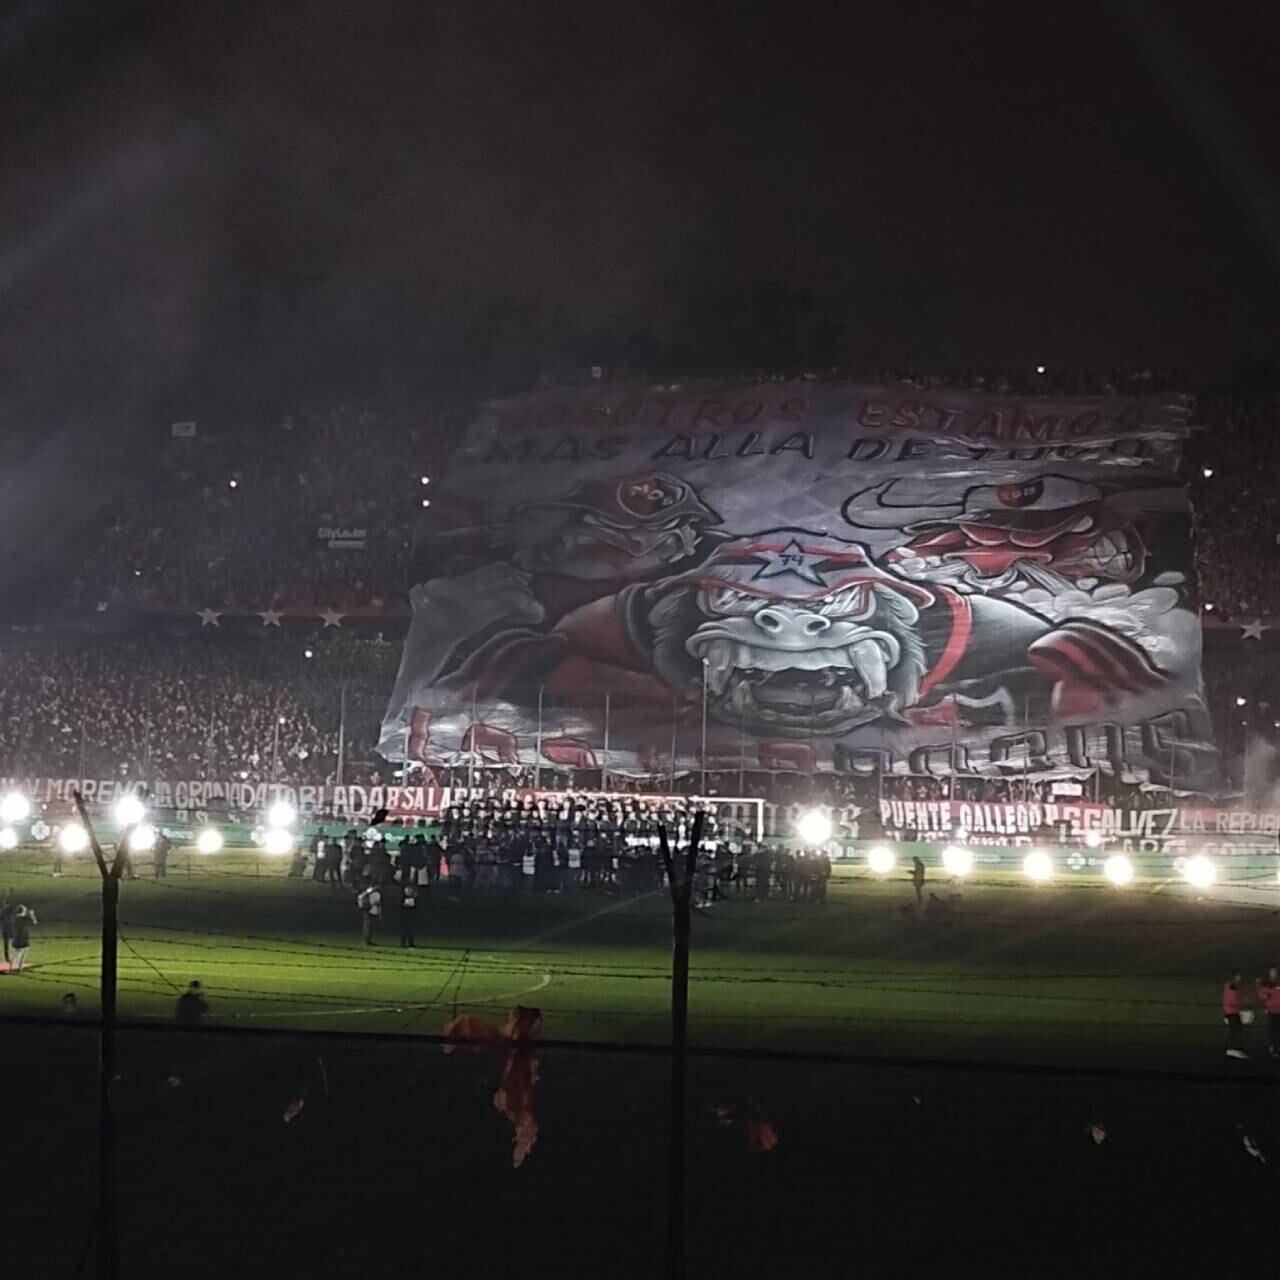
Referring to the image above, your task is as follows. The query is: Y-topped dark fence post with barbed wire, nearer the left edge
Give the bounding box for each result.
[72,787,131,1280]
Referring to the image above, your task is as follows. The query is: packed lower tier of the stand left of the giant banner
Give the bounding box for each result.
[0,631,398,783]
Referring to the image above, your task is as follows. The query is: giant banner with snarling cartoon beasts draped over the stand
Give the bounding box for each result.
[380,381,1216,790]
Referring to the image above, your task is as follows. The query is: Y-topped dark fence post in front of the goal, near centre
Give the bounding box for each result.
[658,813,703,1280]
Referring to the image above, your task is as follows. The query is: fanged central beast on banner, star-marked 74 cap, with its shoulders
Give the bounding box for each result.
[471,529,1166,739]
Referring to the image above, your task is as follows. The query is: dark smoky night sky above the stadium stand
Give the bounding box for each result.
[0,0,1280,430]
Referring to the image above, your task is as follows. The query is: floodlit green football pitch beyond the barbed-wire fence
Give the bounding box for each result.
[0,851,1280,1070]
